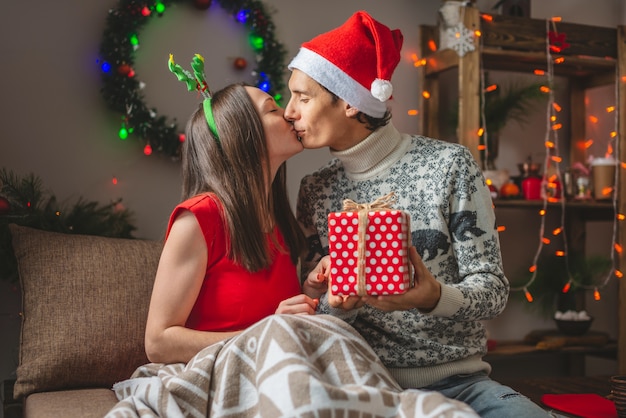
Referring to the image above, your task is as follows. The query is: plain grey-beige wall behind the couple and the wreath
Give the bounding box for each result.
[0,0,626,394]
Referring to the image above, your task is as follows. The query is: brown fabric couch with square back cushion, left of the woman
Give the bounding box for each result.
[9,224,162,418]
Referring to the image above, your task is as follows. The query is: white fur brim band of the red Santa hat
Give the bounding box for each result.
[288,48,391,118]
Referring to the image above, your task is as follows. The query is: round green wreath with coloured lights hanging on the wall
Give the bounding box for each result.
[99,0,286,159]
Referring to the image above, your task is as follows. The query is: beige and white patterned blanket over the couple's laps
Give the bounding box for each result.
[106,315,477,418]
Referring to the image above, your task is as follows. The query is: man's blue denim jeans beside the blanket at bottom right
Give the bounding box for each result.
[421,373,555,418]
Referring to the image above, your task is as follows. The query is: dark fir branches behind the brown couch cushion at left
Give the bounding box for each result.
[0,168,136,283]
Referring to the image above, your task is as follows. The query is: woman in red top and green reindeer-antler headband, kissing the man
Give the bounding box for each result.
[145,56,318,363]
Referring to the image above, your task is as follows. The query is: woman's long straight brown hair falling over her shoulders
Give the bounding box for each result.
[182,83,305,272]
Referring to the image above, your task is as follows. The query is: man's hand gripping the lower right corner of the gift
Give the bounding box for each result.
[363,247,441,312]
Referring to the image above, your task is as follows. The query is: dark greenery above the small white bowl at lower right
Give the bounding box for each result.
[511,254,613,318]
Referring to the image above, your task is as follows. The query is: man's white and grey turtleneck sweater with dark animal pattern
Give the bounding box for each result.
[297,123,510,388]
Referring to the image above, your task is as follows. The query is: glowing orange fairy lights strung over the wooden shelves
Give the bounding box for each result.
[413,12,626,302]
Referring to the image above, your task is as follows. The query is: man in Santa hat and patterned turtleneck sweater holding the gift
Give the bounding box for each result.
[285,12,548,418]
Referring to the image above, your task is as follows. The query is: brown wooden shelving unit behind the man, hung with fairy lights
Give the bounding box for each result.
[419,4,626,373]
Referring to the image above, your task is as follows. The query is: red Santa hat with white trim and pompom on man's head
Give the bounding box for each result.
[289,11,403,118]
